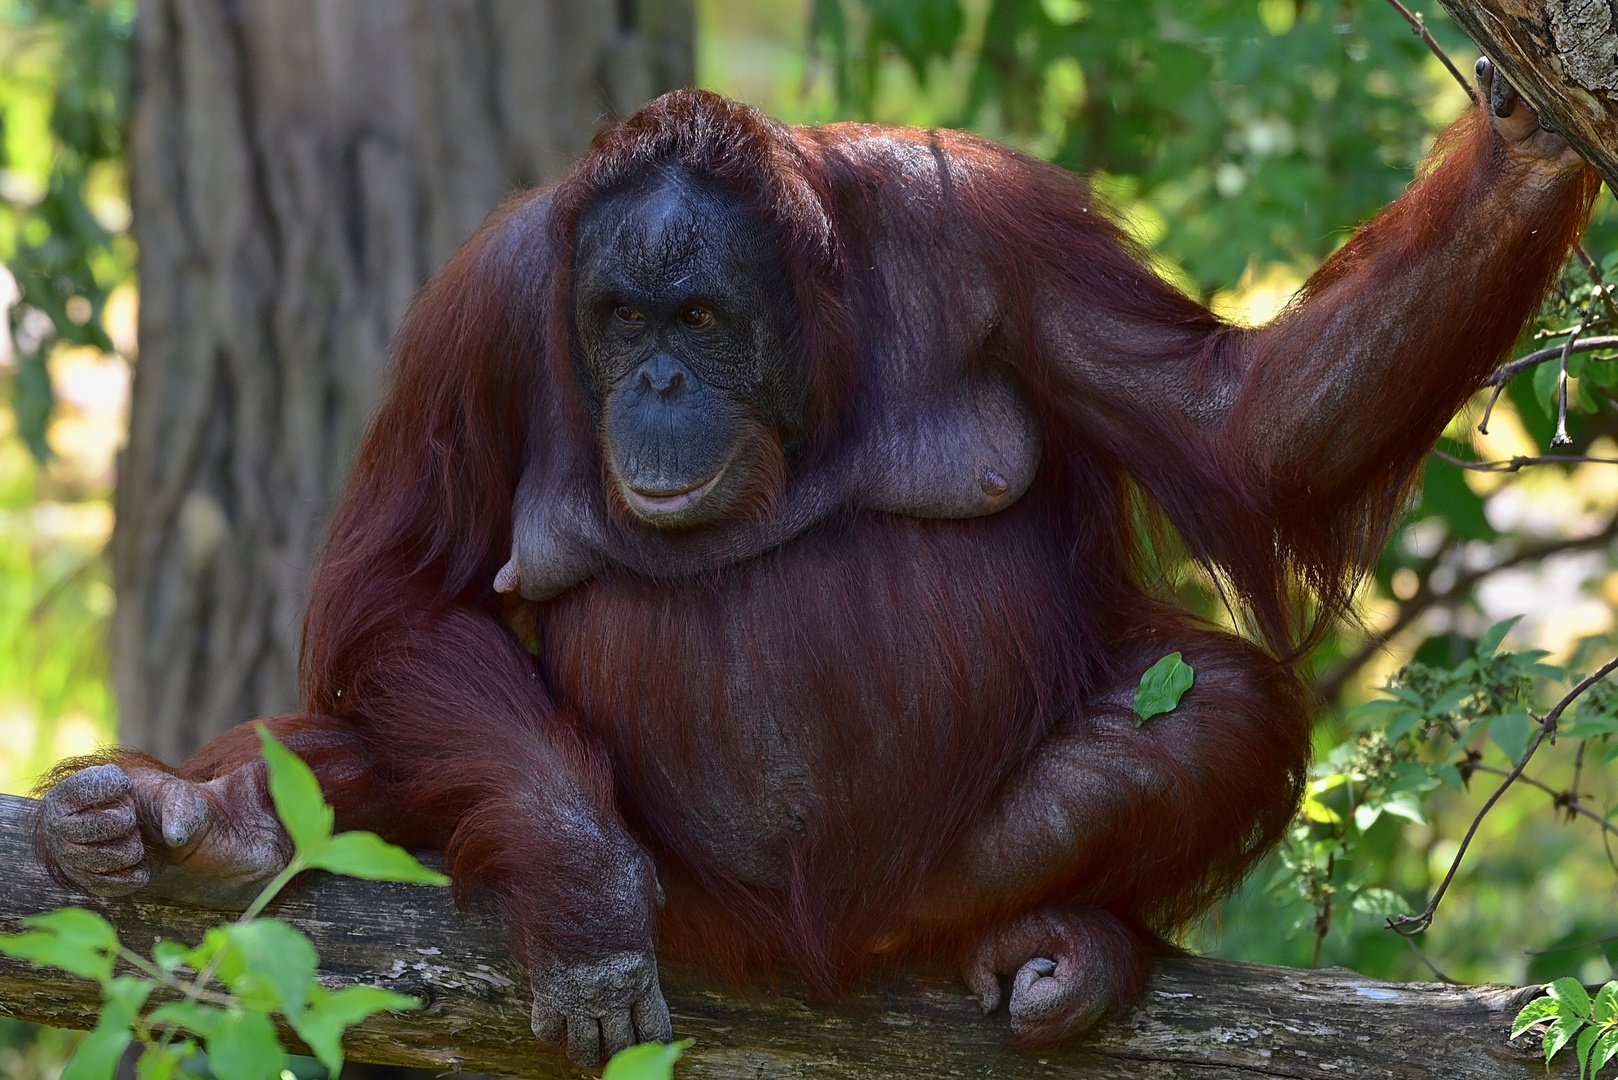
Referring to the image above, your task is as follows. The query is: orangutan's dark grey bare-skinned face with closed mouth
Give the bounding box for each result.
[573,172,803,528]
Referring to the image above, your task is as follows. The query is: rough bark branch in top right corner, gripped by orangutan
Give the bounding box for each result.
[1440,0,1618,186]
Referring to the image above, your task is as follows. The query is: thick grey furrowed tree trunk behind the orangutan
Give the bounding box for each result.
[113,0,694,761]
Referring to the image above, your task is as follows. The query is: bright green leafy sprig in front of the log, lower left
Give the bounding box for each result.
[0,725,443,1080]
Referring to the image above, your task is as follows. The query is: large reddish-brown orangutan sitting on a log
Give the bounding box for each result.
[40,66,1595,1064]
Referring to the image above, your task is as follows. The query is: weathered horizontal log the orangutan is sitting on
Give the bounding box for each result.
[0,795,1571,1080]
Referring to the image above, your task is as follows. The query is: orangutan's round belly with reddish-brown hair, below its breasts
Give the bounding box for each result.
[540,518,1063,886]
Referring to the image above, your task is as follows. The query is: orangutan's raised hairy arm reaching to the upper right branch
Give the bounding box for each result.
[1029,66,1597,641]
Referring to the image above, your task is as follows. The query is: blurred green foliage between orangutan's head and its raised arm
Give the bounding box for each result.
[811,0,1471,291]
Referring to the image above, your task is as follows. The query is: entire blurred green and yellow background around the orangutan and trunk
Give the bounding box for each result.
[0,0,1618,1077]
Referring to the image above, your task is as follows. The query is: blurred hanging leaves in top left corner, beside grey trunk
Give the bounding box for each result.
[0,0,134,460]
